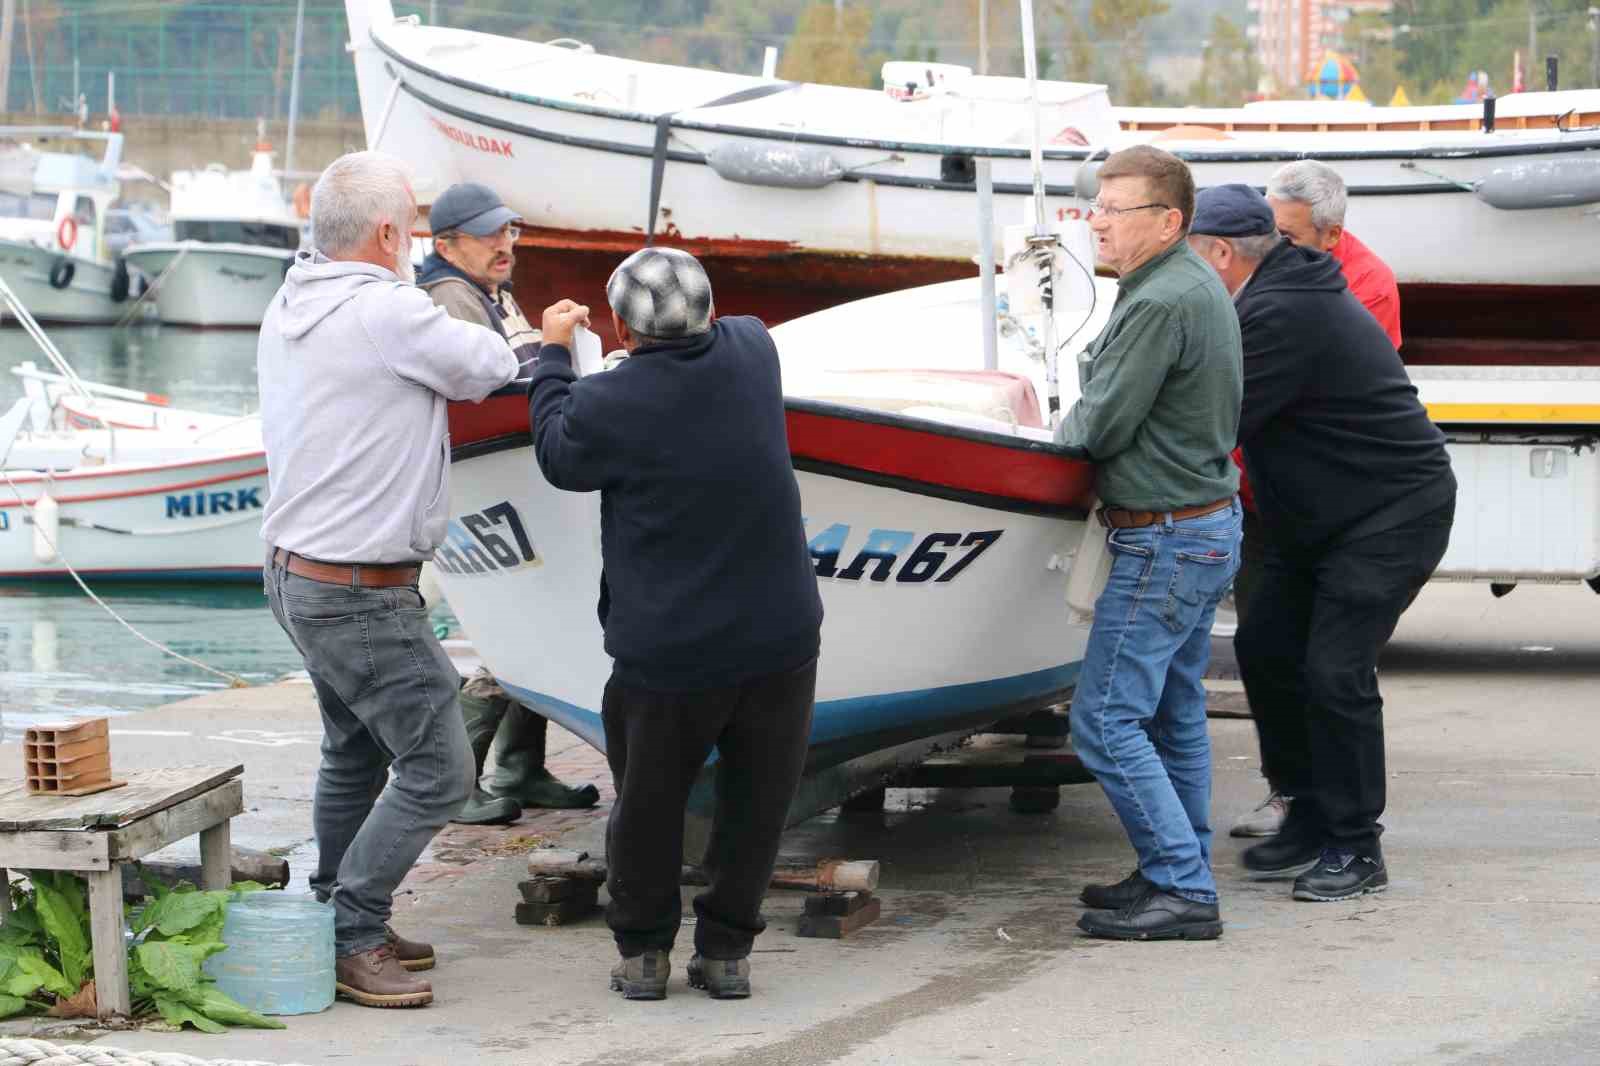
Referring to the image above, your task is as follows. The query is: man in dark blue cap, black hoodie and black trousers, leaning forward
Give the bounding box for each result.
[1189,186,1456,901]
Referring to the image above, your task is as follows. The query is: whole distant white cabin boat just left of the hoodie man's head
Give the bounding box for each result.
[126,142,301,327]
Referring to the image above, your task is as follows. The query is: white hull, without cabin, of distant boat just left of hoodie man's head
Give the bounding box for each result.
[126,240,294,327]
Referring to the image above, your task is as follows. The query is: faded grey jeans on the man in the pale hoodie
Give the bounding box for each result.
[266,559,474,956]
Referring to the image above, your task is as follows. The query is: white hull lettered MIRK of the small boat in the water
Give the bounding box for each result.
[0,450,267,581]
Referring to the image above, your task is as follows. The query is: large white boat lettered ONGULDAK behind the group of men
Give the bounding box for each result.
[346,0,1600,356]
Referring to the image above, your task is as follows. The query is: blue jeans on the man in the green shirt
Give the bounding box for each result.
[1072,499,1242,903]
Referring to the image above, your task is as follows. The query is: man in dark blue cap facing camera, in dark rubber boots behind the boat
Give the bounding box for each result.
[418,181,600,824]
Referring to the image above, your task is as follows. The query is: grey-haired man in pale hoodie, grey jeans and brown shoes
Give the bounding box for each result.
[256,152,517,1007]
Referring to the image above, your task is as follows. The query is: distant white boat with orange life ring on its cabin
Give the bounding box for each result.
[0,126,131,323]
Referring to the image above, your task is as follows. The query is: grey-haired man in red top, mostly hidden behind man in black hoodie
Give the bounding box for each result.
[1230,158,1400,837]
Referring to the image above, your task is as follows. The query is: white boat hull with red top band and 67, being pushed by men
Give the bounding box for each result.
[434,394,1093,818]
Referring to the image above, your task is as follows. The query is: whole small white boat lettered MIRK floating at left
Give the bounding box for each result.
[0,363,267,581]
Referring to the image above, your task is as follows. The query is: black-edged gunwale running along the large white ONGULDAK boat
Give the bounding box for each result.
[368,27,1600,164]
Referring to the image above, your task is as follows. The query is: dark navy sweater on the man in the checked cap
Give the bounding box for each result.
[528,317,822,691]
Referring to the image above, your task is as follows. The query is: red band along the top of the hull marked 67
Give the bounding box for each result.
[450,395,1094,507]
